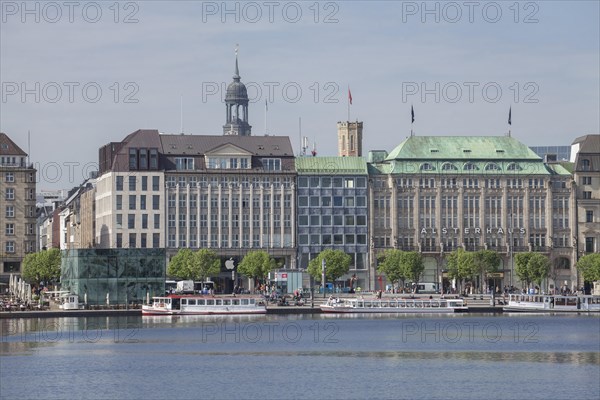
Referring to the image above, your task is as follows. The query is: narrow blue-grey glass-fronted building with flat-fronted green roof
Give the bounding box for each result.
[296,157,371,288]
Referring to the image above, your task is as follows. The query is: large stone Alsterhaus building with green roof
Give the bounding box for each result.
[369,136,577,290]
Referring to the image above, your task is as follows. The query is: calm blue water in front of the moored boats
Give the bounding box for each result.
[0,314,600,400]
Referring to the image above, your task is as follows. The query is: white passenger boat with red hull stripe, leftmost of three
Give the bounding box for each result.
[142,295,267,315]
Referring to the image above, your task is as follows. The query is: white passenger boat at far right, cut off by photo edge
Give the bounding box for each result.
[502,294,600,313]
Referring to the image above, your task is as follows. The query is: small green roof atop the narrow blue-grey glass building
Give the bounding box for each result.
[296,157,367,175]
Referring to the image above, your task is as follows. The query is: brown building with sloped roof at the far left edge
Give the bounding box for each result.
[0,133,37,281]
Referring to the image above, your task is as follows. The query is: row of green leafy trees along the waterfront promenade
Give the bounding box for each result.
[16,249,600,294]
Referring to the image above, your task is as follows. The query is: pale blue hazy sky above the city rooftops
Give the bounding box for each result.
[0,0,600,190]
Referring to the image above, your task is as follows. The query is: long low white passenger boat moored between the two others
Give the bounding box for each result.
[321,297,468,314]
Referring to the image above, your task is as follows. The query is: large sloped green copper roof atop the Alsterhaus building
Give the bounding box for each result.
[386,136,541,161]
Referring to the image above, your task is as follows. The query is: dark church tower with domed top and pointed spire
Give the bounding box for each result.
[223,49,252,136]
